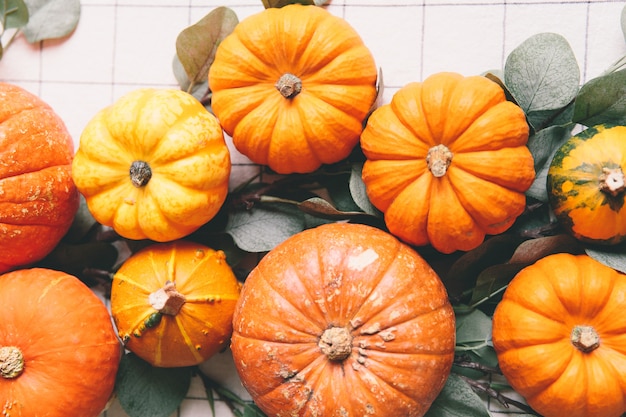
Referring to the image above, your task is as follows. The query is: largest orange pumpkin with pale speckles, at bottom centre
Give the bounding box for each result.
[231,223,455,417]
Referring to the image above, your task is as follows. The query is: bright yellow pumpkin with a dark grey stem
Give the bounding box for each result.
[72,88,231,242]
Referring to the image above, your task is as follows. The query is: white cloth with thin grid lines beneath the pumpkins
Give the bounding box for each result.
[0,0,626,417]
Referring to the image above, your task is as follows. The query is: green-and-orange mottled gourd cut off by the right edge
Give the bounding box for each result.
[547,125,626,245]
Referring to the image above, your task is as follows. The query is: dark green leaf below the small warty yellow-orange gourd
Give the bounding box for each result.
[115,353,192,417]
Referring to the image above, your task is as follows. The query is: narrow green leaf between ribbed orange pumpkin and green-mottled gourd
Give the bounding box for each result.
[526,125,573,203]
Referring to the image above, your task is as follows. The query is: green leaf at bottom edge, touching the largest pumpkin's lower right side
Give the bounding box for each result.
[424,374,490,417]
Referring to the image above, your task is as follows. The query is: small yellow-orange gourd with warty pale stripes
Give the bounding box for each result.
[111,240,241,367]
